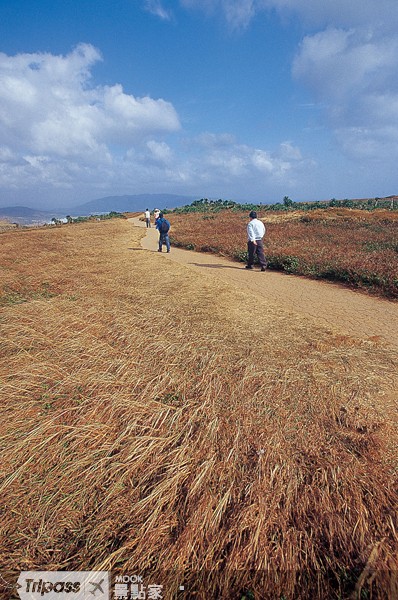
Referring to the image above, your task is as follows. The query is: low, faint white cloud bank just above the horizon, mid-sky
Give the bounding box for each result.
[116,133,314,201]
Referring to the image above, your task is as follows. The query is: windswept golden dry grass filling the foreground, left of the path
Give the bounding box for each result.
[0,220,398,600]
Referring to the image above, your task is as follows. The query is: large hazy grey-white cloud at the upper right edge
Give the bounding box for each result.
[293,29,398,158]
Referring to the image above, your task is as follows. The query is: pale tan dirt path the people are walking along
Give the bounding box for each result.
[129,218,398,349]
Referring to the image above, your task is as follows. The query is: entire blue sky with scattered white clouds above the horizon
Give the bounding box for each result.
[0,0,398,209]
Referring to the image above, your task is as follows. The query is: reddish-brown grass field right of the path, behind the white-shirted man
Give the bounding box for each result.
[171,208,398,298]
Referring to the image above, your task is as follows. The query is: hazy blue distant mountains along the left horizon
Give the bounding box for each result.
[0,194,195,225]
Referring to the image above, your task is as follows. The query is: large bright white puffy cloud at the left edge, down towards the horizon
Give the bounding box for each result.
[0,44,180,205]
